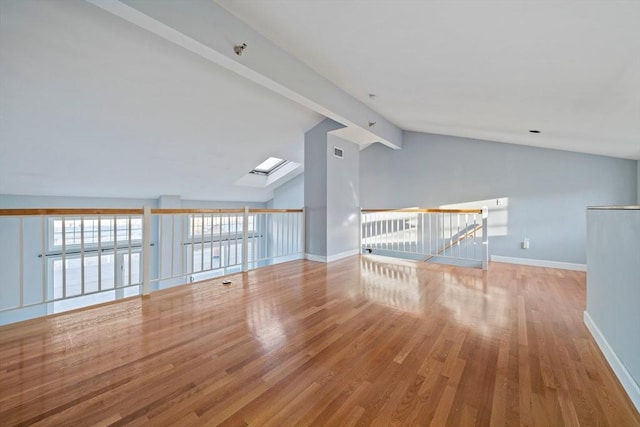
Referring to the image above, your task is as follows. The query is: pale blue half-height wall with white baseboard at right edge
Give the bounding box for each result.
[585,208,640,410]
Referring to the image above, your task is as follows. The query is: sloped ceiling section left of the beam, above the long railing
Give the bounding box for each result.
[0,0,322,201]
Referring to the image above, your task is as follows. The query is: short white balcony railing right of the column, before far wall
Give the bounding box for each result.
[361,208,489,270]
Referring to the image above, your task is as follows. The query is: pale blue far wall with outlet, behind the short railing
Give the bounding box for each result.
[360,132,638,264]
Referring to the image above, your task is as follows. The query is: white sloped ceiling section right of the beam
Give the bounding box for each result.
[217,0,640,159]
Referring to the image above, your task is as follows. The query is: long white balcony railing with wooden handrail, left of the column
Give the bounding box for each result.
[0,208,304,324]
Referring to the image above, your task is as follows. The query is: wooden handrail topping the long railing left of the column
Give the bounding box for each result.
[0,208,303,216]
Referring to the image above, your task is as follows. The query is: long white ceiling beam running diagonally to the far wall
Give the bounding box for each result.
[86,0,402,149]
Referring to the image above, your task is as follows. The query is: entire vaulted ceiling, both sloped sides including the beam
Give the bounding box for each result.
[0,0,640,201]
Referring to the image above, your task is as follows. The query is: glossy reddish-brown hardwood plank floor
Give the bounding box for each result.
[0,256,640,426]
